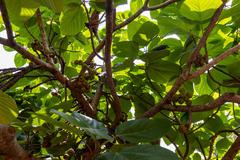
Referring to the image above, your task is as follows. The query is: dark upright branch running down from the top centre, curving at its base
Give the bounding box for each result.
[104,0,122,126]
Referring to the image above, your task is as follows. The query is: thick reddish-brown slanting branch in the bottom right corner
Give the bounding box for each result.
[222,136,240,160]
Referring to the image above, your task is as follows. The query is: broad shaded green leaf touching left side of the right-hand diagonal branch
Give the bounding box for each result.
[147,60,181,83]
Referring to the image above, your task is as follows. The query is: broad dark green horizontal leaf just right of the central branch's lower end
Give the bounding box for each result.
[116,118,171,143]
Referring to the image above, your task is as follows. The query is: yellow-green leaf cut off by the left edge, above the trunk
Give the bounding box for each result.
[0,90,18,124]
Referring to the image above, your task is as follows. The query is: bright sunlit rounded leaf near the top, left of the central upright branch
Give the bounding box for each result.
[60,4,87,35]
